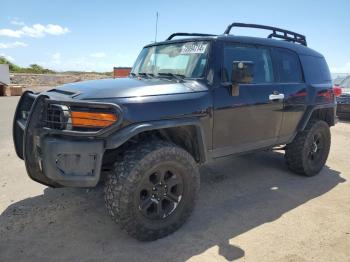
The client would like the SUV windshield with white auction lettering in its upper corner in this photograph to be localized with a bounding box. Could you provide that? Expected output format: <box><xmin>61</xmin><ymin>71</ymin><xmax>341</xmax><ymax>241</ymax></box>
<box><xmin>131</xmin><ymin>41</ymin><xmax>209</xmax><ymax>78</ymax></box>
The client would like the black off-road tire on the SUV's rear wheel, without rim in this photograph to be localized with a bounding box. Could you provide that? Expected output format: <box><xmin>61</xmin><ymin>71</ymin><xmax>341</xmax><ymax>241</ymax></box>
<box><xmin>285</xmin><ymin>120</ymin><xmax>331</xmax><ymax>176</ymax></box>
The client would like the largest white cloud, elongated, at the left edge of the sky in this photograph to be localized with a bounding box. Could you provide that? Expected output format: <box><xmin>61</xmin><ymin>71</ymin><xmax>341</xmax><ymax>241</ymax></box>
<box><xmin>0</xmin><ymin>24</ymin><xmax>70</xmax><ymax>38</ymax></box>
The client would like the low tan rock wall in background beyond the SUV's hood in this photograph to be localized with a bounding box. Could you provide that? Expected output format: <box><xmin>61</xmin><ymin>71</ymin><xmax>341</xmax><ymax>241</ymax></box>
<box><xmin>10</xmin><ymin>73</ymin><xmax>111</xmax><ymax>88</ymax></box>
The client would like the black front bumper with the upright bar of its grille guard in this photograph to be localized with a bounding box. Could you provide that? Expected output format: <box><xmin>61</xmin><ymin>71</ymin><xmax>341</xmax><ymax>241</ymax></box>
<box><xmin>13</xmin><ymin>92</ymin><xmax>105</xmax><ymax>187</ymax></box>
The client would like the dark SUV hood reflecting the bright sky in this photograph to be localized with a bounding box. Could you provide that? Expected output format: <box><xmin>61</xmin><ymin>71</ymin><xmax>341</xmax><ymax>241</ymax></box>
<box><xmin>50</xmin><ymin>78</ymin><xmax>207</xmax><ymax>99</ymax></box>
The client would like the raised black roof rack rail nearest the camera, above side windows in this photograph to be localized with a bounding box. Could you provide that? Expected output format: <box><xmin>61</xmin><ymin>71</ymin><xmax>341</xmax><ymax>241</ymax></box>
<box><xmin>224</xmin><ymin>23</ymin><xmax>307</xmax><ymax>46</ymax></box>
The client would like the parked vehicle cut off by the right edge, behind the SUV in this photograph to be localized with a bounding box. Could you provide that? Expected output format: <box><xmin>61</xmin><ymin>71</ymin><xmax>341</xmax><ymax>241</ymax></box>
<box><xmin>337</xmin><ymin>76</ymin><xmax>350</xmax><ymax>120</ymax></box>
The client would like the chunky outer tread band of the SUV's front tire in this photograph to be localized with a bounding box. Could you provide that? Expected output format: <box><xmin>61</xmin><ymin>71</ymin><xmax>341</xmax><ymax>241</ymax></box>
<box><xmin>105</xmin><ymin>139</ymin><xmax>199</xmax><ymax>241</ymax></box>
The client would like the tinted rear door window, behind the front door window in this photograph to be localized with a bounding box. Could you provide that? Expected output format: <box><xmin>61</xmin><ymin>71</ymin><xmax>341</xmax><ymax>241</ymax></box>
<box><xmin>275</xmin><ymin>49</ymin><xmax>303</xmax><ymax>83</ymax></box>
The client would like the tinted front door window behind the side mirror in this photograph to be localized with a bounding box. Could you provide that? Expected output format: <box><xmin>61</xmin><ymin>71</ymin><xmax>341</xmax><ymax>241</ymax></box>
<box><xmin>222</xmin><ymin>45</ymin><xmax>274</xmax><ymax>84</ymax></box>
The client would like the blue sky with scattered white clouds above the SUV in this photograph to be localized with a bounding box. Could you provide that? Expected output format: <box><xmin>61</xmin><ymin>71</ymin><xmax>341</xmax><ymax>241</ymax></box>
<box><xmin>0</xmin><ymin>0</ymin><xmax>350</xmax><ymax>73</ymax></box>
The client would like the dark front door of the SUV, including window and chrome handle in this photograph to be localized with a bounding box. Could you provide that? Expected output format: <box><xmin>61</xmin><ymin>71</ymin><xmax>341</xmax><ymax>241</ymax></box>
<box><xmin>213</xmin><ymin>43</ymin><xmax>284</xmax><ymax>157</ymax></box>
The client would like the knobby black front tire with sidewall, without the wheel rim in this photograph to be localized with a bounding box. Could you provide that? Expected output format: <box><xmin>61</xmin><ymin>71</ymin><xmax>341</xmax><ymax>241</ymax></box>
<box><xmin>105</xmin><ymin>140</ymin><xmax>200</xmax><ymax>241</ymax></box>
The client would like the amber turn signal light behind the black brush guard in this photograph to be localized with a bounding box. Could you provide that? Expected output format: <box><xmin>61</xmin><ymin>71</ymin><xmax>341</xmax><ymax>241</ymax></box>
<box><xmin>71</xmin><ymin>111</ymin><xmax>118</xmax><ymax>127</ymax></box>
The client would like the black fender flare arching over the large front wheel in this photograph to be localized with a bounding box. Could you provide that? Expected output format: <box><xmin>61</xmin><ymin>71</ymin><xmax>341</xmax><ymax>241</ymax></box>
<box><xmin>105</xmin><ymin>118</ymin><xmax>207</xmax><ymax>163</ymax></box>
